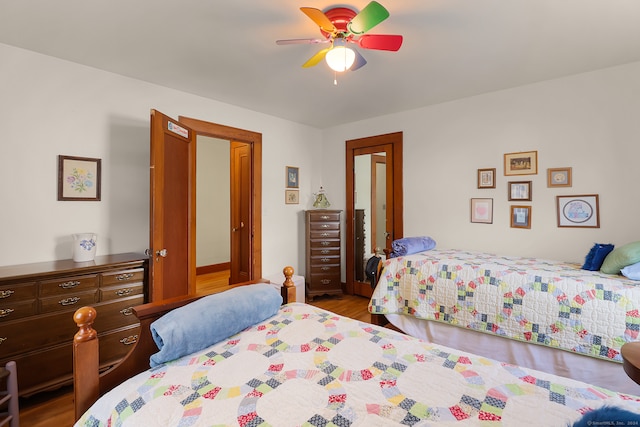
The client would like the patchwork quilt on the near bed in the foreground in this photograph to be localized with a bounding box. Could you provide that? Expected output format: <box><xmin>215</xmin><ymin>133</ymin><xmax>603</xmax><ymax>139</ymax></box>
<box><xmin>76</xmin><ymin>303</ymin><xmax>640</xmax><ymax>427</ymax></box>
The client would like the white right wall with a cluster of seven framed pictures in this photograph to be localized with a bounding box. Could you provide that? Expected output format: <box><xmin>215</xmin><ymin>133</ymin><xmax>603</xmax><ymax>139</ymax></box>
<box><xmin>323</xmin><ymin>63</ymin><xmax>640</xmax><ymax>262</ymax></box>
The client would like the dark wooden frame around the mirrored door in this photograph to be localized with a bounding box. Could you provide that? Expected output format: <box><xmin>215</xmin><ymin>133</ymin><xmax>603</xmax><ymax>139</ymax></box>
<box><xmin>345</xmin><ymin>132</ymin><xmax>404</xmax><ymax>295</ymax></box>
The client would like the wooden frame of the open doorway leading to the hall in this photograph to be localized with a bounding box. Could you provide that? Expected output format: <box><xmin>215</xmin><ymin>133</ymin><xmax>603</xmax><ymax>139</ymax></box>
<box><xmin>178</xmin><ymin>116</ymin><xmax>262</xmax><ymax>280</ymax></box>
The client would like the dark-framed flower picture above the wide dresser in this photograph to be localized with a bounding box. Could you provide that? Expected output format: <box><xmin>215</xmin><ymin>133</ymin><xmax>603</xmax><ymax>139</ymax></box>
<box><xmin>58</xmin><ymin>155</ymin><xmax>101</xmax><ymax>201</ymax></box>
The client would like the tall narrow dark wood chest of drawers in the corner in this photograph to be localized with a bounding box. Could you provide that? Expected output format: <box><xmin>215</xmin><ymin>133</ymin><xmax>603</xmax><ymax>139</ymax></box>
<box><xmin>305</xmin><ymin>209</ymin><xmax>342</xmax><ymax>301</ymax></box>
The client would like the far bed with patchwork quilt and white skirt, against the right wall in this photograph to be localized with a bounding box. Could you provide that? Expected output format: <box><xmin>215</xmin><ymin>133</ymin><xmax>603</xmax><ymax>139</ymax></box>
<box><xmin>369</xmin><ymin>249</ymin><xmax>640</xmax><ymax>393</ymax></box>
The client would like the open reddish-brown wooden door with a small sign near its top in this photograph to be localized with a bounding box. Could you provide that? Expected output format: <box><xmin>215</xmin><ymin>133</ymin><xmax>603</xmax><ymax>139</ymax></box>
<box><xmin>149</xmin><ymin>110</ymin><xmax>196</xmax><ymax>301</ymax></box>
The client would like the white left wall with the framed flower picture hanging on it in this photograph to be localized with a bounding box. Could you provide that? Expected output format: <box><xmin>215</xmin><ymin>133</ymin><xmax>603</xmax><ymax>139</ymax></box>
<box><xmin>0</xmin><ymin>44</ymin><xmax>321</xmax><ymax>275</ymax></box>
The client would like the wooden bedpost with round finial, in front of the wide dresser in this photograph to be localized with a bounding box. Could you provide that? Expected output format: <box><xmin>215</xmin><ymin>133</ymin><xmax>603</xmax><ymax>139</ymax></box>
<box><xmin>73</xmin><ymin>307</ymin><xmax>100</xmax><ymax>420</ymax></box>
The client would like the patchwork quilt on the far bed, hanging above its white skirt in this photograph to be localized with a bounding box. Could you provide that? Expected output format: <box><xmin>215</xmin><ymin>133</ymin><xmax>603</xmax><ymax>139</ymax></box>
<box><xmin>369</xmin><ymin>249</ymin><xmax>640</xmax><ymax>362</ymax></box>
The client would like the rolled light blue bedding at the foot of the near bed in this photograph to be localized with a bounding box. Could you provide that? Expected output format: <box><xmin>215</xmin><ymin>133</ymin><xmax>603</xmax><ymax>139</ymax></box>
<box><xmin>150</xmin><ymin>284</ymin><xmax>282</xmax><ymax>368</ymax></box>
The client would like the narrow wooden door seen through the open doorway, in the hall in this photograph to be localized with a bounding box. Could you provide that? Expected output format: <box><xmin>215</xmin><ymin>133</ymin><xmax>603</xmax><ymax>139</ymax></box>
<box><xmin>229</xmin><ymin>141</ymin><xmax>253</xmax><ymax>284</ymax></box>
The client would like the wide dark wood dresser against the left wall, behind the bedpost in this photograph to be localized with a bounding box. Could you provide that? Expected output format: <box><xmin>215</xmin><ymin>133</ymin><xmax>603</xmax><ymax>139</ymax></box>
<box><xmin>0</xmin><ymin>253</ymin><xmax>148</xmax><ymax>396</ymax></box>
